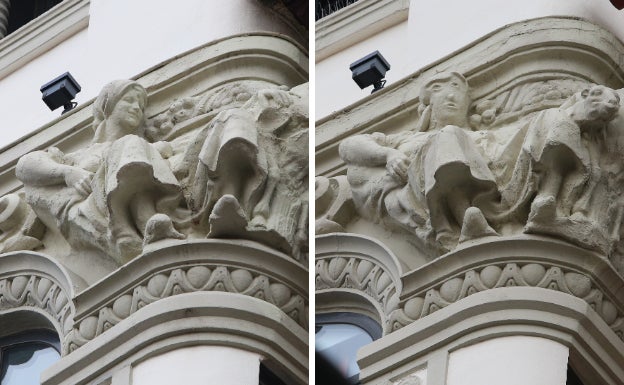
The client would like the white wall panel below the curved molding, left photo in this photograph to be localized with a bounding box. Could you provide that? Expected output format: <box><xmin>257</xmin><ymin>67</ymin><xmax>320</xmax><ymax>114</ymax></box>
<box><xmin>131</xmin><ymin>346</ymin><xmax>261</xmax><ymax>385</ymax></box>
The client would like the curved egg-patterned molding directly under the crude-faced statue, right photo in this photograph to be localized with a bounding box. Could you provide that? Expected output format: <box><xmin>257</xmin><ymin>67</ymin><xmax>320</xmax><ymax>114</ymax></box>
<box><xmin>386</xmin><ymin>235</ymin><xmax>624</xmax><ymax>339</ymax></box>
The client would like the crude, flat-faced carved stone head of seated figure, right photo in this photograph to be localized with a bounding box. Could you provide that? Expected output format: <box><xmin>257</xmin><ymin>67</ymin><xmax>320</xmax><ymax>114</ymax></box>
<box><xmin>420</xmin><ymin>72</ymin><xmax>471</xmax><ymax>129</ymax></box>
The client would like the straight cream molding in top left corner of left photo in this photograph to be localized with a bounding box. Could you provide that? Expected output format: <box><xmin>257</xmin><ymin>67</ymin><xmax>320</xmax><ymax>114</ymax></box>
<box><xmin>0</xmin><ymin>0</ymin><xmax>91</xmax><ymax>79</ymax></box>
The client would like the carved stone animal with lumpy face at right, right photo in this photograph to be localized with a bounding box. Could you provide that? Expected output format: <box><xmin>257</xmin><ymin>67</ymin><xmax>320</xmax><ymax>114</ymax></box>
<box><xmin>514</xmin><ymin>85</ymin><xmax>620</xmax><ymax>252</ymax></box>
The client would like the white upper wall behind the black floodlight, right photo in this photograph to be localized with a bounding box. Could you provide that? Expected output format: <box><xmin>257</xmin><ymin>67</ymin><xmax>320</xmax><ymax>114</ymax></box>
<box><xmin>315</xmin><ymin>0</ymin><xmax>624</xmax><ymax>119</ymax></box>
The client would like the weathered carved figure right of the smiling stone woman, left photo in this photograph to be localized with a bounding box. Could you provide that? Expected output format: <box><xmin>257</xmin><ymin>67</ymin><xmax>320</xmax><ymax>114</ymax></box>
<box><xmin>178</xmin><ymin>85</ymin><xmax>308</xmax><ymax>255</ymax></box>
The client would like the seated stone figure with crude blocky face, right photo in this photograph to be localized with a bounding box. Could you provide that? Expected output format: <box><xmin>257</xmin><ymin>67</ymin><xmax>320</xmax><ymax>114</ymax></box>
<box><xmin>340</xmin><ymin>72</ymin><xmax>498</xmax><ymax>251</ymax></box>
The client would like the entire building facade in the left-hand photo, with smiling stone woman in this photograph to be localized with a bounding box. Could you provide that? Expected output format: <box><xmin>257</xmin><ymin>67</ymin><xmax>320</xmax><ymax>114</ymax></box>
<box><xmin>0</xmin><ymin>0</ymin><xmax>308</xmax><ymax>385</ymax></box>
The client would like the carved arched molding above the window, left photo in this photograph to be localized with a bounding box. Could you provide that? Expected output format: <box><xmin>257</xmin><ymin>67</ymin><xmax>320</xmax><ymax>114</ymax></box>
<box><xmin>0</xmin><ymin>251</ymin><xmax>78</xmax><ymax>340</ymax></box>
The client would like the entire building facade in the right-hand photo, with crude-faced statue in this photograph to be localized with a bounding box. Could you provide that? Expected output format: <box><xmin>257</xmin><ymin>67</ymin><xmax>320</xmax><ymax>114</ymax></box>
<box><xmin>315</xmin><ymin>0</ymin><xmax>624</xmax><ymax>385</ymax></box>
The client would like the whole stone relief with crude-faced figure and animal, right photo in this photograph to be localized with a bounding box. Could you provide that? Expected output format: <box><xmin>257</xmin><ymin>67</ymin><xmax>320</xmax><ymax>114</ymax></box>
<box><xmin>334</xmin><ymin>73</ymin><xmax>624</xmax><ymax>273</ymax></box>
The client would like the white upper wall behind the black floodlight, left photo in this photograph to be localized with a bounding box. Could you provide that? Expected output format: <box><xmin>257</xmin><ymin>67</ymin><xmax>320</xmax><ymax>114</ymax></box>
<box><xmin>0</xmin><ymin>0</ymin><xmax>300</xmax><ymax>147</ymax></box>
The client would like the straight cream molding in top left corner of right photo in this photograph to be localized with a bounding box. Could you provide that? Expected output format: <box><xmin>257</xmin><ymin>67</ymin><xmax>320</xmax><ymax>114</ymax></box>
<box><xmin>315</xmin><ymin>0</ymin><xmax>410</xmax><ymax>62</ymax></box>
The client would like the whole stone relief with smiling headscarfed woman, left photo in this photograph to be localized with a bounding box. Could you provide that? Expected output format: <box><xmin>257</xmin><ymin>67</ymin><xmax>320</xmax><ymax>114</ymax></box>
<box><xmin>11</xmin><ymin>80</ymin><xmax>308</xmax><ymax>264</ymax></box>
